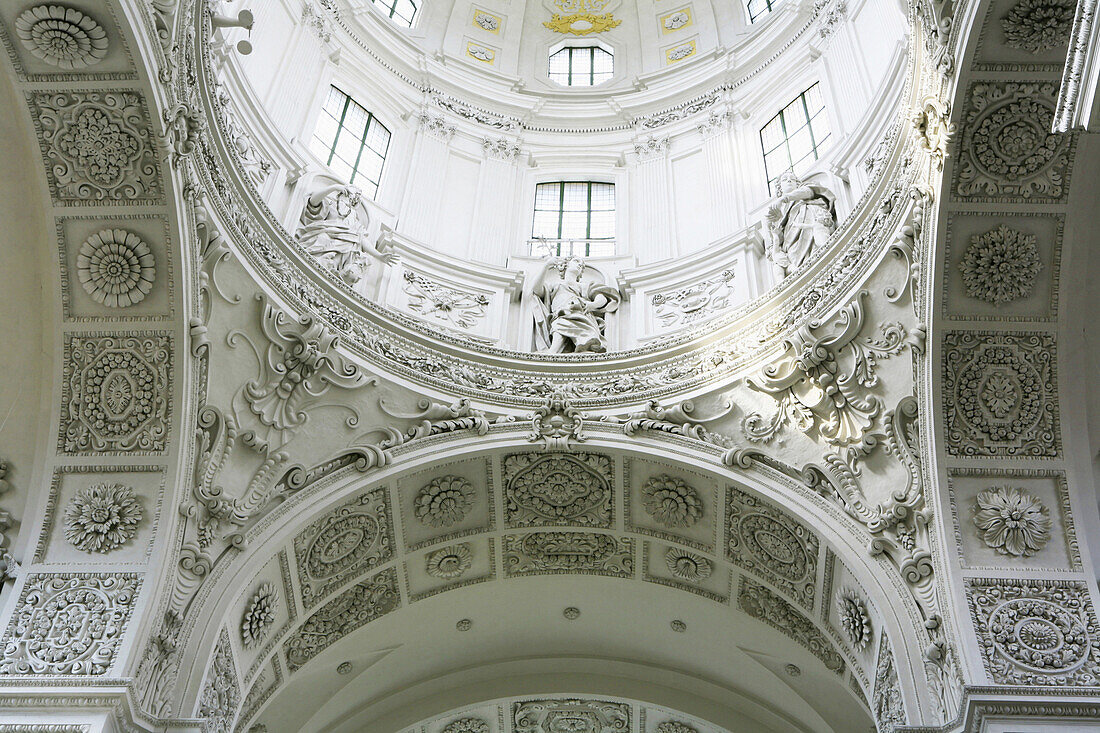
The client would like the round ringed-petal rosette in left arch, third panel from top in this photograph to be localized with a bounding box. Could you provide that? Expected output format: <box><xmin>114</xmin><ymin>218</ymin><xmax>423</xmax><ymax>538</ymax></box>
<box><xmin>76</xmin><ymin>229</ymin><xmax>156</xmax><ymax>308</ymax></box>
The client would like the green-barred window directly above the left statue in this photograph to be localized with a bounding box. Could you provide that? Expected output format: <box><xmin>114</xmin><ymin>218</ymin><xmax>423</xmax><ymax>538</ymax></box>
<box><xmin>309</xmin><ymin>87</ymin><xmax>389</xmax><ymax>198</ymax></box>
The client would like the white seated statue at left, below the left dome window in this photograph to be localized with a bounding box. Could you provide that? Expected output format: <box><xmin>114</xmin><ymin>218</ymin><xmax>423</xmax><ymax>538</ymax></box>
<box><xmin>296</xmin><ymin>184</ymin><xmax>398</xmax><ymax>285</ymax></box>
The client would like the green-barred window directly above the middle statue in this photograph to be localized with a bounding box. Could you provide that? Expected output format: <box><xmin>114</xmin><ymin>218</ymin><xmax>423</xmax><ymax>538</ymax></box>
<box><xmin>531</xmin><ymin>180</ymin><xmax>615</xmax><ymax>256</ymax></box>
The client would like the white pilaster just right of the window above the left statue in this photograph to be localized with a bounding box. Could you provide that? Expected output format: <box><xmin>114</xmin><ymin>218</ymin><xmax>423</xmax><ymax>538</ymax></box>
<box><xmin>396</xmin><ymin>111</ymin><xmax>454</xmax><ymax>242</ymax></box>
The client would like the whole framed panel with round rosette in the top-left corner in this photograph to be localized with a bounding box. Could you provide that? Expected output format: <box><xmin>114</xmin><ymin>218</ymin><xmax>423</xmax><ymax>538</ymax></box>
<box><xmin>0</xmin><ymin>0</ymin><xmax>138</xmax><ymax>81</ymax></box>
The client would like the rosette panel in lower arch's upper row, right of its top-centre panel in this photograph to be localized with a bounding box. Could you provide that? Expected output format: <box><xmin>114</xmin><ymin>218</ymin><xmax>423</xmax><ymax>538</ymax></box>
<box><xmin>624</xmin><ymin>458</ymin><xmax>719</xmax><ymax>553</ymax></box>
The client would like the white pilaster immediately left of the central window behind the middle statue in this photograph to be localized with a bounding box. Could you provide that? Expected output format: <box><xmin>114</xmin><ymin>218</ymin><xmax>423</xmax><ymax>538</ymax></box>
<box><xmin>470</xmin><ymin>138</ymin><xmax>520</xmax><ymax>267</ymax></box>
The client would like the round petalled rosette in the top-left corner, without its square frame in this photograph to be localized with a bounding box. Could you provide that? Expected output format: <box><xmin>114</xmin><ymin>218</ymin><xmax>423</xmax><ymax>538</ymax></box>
<box><xmin>15</xmin><ymin>4</ymin><xmax>109</xmax><ymax>69</ymax></box>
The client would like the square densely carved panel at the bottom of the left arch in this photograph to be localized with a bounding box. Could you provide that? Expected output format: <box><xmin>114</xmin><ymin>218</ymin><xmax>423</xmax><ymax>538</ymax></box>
<box><xmin>0</xmin><ymin>573</ymin><xmax>141</xmax><ymax>675</ymax></box>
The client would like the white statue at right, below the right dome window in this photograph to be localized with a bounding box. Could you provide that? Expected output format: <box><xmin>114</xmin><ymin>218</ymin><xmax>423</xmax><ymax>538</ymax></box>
<box><xmin>763</xmin><ymin>171</ymin><xmax>836</xmax><ymax>277</ymax></box>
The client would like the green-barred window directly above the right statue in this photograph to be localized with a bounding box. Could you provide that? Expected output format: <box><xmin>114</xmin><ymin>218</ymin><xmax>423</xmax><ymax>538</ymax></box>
<box><xmin>760</xmin><ymin>84</ymin><xmax>829</xmax><ymax>190</ymax></box>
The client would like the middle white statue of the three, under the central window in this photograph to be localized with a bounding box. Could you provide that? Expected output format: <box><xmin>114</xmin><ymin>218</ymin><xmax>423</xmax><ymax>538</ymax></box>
<box><xmin>525</xmin><ymin>258</ymin><xmax>622</xmax><ymax>353</ymax></box>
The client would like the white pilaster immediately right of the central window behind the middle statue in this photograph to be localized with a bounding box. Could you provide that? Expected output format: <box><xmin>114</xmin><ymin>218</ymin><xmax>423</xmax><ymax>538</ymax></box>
<box><xmin>627</xmin><ymin>138</ymin><xmax>679</xmax><ymax>264</ymax></box>
